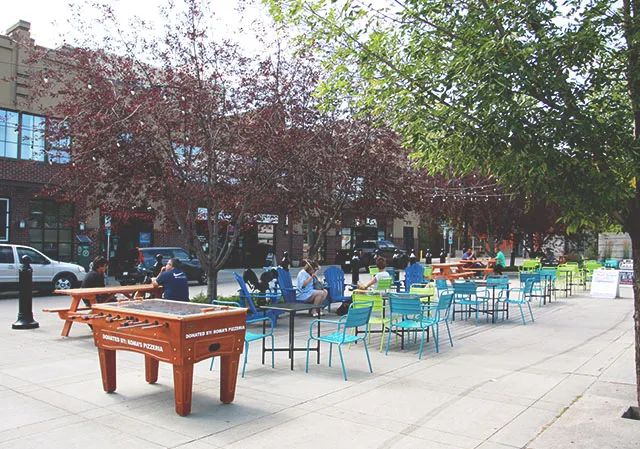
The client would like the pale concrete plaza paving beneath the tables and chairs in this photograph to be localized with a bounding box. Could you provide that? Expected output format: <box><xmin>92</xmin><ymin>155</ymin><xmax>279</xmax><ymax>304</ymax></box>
<box><xmin>0</xmin><ymin>287</ymin><xmax>640</xmax><ymax>449</ymax></box>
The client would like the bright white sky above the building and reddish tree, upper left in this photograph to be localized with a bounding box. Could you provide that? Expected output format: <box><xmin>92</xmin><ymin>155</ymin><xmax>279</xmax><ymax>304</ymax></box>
<box><xmin>0</xmin><ymin>0</ymin><xmax>270</xmax><ymax>48</ymax></box>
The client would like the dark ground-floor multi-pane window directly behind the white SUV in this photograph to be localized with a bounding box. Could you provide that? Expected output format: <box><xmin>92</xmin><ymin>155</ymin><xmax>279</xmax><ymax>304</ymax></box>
<box><xmin>29</xmin><ymin>200</ymin><xmax>73</xmax><ymax>262</ymax></box>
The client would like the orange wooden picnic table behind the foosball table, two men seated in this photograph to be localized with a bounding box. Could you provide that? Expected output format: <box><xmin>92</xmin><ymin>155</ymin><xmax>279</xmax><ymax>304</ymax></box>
<box><xmin>42</xmin><ymin>284</ymin><xmax>162</xmax><ymax>337</ymax></box>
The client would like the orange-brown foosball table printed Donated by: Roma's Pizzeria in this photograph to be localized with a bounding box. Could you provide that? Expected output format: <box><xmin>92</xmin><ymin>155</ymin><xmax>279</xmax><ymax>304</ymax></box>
<box><xmin>92</xmin><ymin>299</ymin><xmax>247</xmax><ymax>416</ymax></box>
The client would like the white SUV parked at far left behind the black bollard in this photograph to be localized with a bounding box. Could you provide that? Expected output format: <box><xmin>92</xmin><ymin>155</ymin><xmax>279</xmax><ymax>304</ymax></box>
<box><xmin>0</xmin><ymin>244</ymin><xmax>86</xmax><ymax>291</ymax></box>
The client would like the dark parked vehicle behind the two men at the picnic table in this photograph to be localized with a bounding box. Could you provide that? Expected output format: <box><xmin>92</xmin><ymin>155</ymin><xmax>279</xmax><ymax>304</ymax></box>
<box><xmin>116</xmin><ymin>246</ymin><xmax>207</xmax><ymax>285</ymax></box>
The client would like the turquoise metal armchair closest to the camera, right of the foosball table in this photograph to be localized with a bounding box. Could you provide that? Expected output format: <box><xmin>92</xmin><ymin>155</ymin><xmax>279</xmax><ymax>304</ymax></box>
<box><xmin>305</xmin><ymin>301</ymin><xmax>373</xmax><ymax>380</ymax></box>
